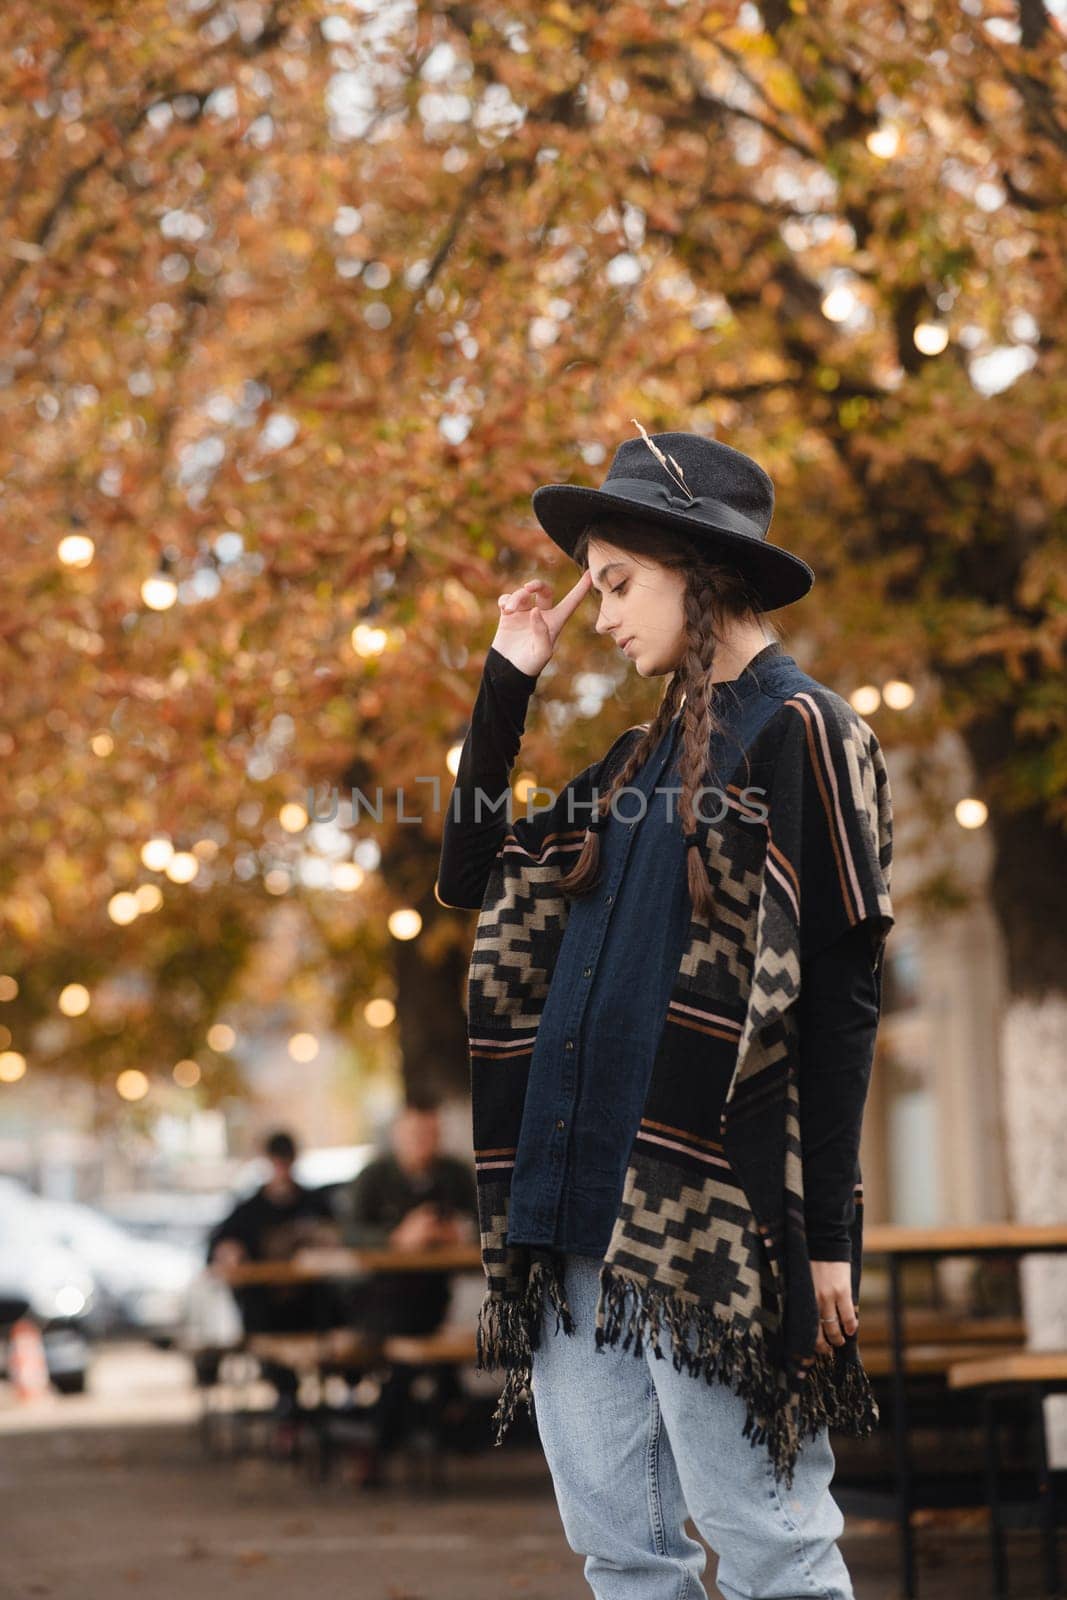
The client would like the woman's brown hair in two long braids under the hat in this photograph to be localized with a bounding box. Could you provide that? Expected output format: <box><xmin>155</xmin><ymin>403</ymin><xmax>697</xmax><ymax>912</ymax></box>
<box><xmin>560</xmin><ymin>517</ymin><xmax>777</xmax><ymax>922</ymax></box>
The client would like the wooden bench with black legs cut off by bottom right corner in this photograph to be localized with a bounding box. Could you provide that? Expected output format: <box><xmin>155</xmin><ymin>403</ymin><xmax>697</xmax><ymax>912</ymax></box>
<box><xmin>949</xmin><ymin>1350</ymin><xmax>1067</xmax><ymax>1600</ymax></box>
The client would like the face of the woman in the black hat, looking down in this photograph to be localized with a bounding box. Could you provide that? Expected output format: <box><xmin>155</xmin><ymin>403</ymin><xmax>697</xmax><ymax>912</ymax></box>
<box><xmin>585</xmin><ymin>539</ymin><xmax>685</xmax><ymax>678</ymax></box>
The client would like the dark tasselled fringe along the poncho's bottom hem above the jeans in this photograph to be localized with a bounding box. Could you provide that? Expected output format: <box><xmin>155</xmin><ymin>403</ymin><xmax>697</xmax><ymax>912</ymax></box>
<box><xmin>477</xmin><ymin>1256</ymin><xmax>878</xmax><ymax>1488</ymax></box>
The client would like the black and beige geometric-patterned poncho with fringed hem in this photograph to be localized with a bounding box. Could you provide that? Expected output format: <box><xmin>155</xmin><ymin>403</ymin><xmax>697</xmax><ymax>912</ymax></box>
<box><xmin>467</xmin><ymin>675</ymin><xmax>894</xmax><ymax>1483</ymax></box>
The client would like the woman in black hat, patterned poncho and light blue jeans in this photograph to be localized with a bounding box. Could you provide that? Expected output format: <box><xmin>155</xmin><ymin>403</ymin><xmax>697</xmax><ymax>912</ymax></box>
<box><xmin>438</xmin><ymin>424</ymin><xmax>893</xmax><ymax>1600</ymax></box>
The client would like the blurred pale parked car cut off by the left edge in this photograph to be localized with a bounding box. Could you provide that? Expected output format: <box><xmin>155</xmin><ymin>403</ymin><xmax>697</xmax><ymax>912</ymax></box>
<box><xmin>0</xmin><ymin>1178</ymin><xmax>96</xmax><ymax>1394</ymax></box>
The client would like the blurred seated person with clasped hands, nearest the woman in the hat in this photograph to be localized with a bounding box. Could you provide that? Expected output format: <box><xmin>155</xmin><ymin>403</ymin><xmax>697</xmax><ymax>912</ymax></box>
<box><xmin>338</xmin><ymin>1094</ymin><xmax>478</xmax><ymax>1485</ymax></box>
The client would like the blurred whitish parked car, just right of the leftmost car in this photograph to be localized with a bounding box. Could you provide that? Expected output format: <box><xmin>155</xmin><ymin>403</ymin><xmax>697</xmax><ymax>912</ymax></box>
<box><xmin>40</xmin><ymin>1200</ymin><xmax>203</xmax><ymax>1346</ymax></box>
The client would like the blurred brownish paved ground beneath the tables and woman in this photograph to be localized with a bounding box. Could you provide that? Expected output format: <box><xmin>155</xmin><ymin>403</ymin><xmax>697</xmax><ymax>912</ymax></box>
<box><xmin>0</xmin><ymin>1349</ymin><xmax>1040</xmax><ymax>1600</ymax></box>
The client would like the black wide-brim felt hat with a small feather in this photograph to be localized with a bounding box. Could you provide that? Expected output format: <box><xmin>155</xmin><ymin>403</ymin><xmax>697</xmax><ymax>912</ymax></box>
<box><xmin>533</xmin><ymin>422</ymin><xmax>816</xmax><ymax>611</ymax></box>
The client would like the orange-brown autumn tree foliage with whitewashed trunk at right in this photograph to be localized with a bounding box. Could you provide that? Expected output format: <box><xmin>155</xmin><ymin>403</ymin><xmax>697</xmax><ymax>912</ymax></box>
<box><xmin>0</xmin><ymin>0</ymin><xmax>1067</xmax><ymax>1299</ymax></box>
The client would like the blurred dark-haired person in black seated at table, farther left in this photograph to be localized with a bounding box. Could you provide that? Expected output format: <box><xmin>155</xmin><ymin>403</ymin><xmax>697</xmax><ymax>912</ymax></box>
<box><xmin>208</xmin><ymin>1131</ymin><xmax>342</xmax><ymax>1411</ymax></box>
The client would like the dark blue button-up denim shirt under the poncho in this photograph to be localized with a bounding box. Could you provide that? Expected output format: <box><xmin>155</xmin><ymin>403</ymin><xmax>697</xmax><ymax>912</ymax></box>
<box><xmin>507</xmin><ymin>642</ymin><xmax>797</xmax><ymax>1258</ymax></box>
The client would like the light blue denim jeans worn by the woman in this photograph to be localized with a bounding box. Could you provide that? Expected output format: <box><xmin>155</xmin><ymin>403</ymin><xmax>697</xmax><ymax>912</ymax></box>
<box><xmin>531</xmin><ymin>1254</ymin><xmax>853</xmax><ymax>1600</ymax></box>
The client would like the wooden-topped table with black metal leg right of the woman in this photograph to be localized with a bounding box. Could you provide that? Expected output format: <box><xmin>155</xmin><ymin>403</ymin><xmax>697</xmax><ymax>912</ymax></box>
<box><xmin>861</xmin><ymin>1222</ymin><xmax>1067</xmax><ymax>1600</ymax></box>
